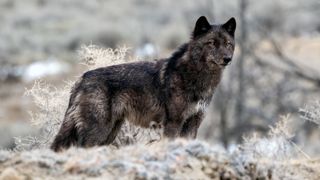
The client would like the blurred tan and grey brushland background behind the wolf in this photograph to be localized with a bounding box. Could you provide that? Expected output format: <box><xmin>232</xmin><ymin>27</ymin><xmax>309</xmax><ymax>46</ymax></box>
<box><xmin>0</xmin><ymin>0</ymin><xmax>320</xmax><ymax>154</ymax></box>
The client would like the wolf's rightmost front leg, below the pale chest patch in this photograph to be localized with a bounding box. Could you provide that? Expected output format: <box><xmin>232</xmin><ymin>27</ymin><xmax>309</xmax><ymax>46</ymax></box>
<box><xmin>180</xmin><ymin>111</ymin><xmax>203</xmax><ymax>139</ymax></box>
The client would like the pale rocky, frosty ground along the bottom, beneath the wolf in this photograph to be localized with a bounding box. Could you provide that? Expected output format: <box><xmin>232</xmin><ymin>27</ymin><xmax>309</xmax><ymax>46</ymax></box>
<box><xmin>0</xmin><ymin>140</ymin><xmax>320</xmax><ymax>180</ymax></box>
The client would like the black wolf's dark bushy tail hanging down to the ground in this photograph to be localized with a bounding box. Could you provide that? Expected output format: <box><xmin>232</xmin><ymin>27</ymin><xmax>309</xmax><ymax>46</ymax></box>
<box><xmin>50</xmin><ymin>121</ymin><xmax>78</xmax><ymax>152</ymax></box>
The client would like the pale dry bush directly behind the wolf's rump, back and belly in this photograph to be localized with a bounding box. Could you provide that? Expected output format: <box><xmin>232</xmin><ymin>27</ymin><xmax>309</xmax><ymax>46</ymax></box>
<box><xmin>16</xmin><ymin>45</ymin><xmax>161</xmax><ymax>150</ymax></box>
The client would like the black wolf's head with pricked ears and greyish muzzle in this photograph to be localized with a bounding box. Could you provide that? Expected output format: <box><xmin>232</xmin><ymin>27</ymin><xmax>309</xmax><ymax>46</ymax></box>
<box><xmin>190</xmin><ymin>16</ymin><xmax>236</xmax><ymax>68</ymax></box>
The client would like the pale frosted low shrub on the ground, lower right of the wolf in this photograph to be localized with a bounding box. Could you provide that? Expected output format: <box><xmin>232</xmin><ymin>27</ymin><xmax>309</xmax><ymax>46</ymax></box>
<box><xmin>231</xmin><ymin>116</ymin><xmax>311</xmax><ymax>179</ymax></box>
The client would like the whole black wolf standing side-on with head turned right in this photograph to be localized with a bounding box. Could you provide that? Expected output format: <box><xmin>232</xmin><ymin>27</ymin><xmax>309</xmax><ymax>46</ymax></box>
<box><xmin>51</xmin><ymin>16</ymin><xmax>236</xmax><ymax>151</ymax></box>
